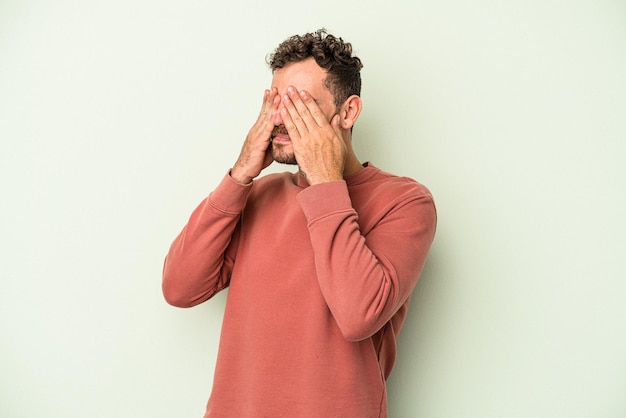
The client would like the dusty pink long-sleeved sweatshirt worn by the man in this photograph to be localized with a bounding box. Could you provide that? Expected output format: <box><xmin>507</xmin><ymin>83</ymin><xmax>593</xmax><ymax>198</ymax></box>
<box><xmin>163</xmin><ymin>164</ymin><xmax>436</xmax><ymax>418</ymax></box>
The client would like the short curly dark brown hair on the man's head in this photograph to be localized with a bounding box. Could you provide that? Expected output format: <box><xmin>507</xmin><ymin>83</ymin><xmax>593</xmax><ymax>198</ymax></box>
<box><xmin>267</xmin><ymin>29</ymin><xmax>363</xmax><ymax>107</ymax></box>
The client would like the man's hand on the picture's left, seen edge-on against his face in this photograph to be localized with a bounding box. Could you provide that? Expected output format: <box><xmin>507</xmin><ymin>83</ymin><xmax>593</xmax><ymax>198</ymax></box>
<box><xmin>230</xmin><ymin>88</ymin><xmax>280</xmax><ymax>184</ymax></box>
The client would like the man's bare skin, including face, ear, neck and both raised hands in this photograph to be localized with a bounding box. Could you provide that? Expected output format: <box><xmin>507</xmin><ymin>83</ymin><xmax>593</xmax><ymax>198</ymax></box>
<box><xmin>230</xmin><ymin>58</ymin><xmax>363</xmax><ymax>185</ymax></box>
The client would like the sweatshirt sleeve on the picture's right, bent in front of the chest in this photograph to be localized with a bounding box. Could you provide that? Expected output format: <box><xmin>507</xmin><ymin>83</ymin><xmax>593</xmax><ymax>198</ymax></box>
<box><xmin>297</xmin><ymin>181</ymin><xmax>436</xmax><ymax>341</ymax></box>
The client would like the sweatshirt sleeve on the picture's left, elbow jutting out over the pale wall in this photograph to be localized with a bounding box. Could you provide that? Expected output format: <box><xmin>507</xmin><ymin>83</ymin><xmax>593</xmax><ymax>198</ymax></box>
<box><xmin>162</xmin><ymin>174</ymin><xmax>251</xmax><ymax>308</ymax></box>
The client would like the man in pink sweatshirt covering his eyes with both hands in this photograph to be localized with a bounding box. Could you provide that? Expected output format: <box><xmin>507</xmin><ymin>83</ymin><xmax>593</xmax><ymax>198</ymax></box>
<box><xmin>163</xmin><ymin>30</ymin><xmax>436</xmax><ymax>418</ymax></box>
